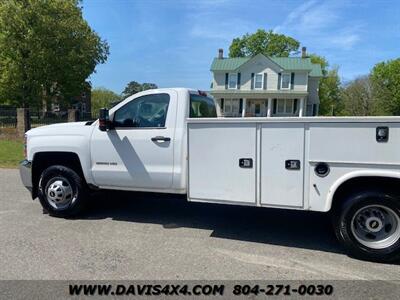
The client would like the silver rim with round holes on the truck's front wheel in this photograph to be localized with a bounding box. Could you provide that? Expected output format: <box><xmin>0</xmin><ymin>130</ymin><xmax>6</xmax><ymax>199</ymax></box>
<box><xmin>46</xmin><ymin>177</ymin><xmax>77</xmax><ymax>210</ymax></box>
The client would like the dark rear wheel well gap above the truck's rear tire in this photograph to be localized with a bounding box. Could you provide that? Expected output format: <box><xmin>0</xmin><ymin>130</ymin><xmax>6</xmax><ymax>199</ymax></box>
<box><xmin>331</xmin><ymin>176</ymin><xmax>400</xmax><ymax>209</ymax></box>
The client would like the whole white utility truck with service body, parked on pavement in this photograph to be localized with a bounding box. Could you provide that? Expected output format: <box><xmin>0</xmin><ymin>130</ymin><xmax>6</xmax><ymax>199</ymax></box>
<box><xmin>20</xmin><ymin>88</ymin><xmax>400</xmax><ymax>261</ymax></box>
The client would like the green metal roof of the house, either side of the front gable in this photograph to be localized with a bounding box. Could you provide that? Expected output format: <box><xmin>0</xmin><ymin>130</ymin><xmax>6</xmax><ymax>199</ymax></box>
<box><xmin>211</xmin><ymin>56</ymin><xmax>322</xmax><ymax>76</ymax></box>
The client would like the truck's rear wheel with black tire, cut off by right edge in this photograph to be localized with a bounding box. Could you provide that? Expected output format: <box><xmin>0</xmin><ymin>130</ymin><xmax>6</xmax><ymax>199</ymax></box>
<box><xmin>333</xmin><ymin>190</ymin><xmax>400</xmax><ymax>262</ymax></box>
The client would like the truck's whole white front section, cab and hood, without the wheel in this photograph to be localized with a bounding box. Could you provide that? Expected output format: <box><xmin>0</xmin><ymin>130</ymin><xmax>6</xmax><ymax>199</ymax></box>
<box><xmin>21</xmin><ymin>88</ymin><xmax>217</xmax><ymax>198</ymax></box>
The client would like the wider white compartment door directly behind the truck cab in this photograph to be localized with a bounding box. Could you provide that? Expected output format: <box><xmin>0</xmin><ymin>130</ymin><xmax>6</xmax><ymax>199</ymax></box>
<box><xmin>188</xmin><ymin>123</ymin><xmax>256</xmax><ymax>205</ymax></box>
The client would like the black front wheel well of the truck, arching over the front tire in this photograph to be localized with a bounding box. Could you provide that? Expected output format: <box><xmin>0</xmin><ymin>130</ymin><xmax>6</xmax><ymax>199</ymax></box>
<box><xmin>32</xmin><ymin>152</ymin><xmax>85</xmax><ymax>198</ymax></box>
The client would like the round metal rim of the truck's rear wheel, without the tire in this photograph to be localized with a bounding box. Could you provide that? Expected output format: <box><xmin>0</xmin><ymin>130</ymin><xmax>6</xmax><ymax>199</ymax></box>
<box><xmin>351</xmin><ymin>205</ymin><xmax>400</xmax><ymax>249</ymax></box>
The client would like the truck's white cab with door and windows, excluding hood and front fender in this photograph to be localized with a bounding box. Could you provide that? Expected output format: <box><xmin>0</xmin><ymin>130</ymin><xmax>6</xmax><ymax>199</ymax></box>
<box><xmin>90</xmin><ymin>89</ymin><xmax>216</xmax><ymax>194</ymax></box>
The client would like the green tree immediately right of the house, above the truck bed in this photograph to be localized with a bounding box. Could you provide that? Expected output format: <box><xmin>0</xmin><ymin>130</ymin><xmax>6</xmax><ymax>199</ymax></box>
<box><xmin>308</xmin><ymin>54</ymin><xmax>343</xmax><ymax>116</ymax></box>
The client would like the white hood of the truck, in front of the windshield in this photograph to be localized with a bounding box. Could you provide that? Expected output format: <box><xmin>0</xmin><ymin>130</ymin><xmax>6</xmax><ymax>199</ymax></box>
<box><xmin>26</xmin><ymin>122</ymin><xmax>93</xmax><ymax>136</ymax></box>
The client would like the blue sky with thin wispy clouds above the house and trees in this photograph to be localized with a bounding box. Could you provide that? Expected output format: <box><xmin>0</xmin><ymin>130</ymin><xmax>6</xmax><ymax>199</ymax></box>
<box><xmin>82</xmin><ymin>0</ymin><xmax>400</xmax><ymax>94</ymax></box>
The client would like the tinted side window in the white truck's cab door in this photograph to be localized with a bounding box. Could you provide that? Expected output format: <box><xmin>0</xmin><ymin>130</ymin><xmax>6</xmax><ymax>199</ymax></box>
<box><xmin>114</xmin><ymin>94</ymin><xmax>169</xmax><ymax>128</ymax></box>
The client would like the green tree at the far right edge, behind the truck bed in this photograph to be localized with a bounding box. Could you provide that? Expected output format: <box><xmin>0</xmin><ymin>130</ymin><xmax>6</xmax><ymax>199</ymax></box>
<box><xmin>371</xmin><ymin>58</ymin><xmax>400</xmax><ymax>116</ymax></box>
